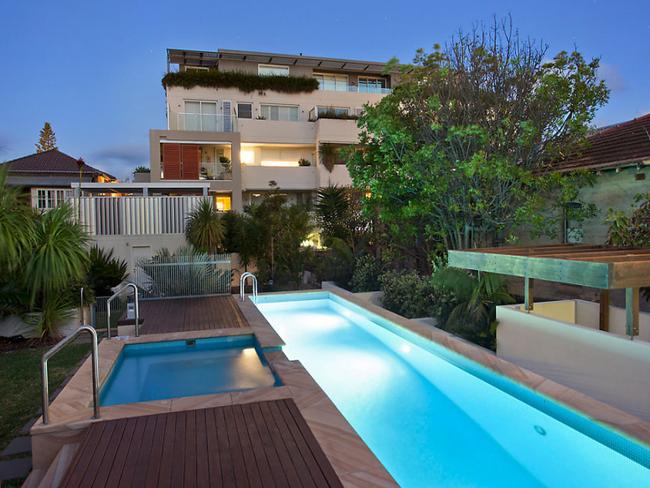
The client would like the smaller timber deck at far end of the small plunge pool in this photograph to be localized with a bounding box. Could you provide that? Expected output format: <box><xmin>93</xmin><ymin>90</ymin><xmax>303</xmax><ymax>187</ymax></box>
<box><xmin>140</xmin><ymin>296</ymin><xmax>248</xmax><ymax>334</ymax></box>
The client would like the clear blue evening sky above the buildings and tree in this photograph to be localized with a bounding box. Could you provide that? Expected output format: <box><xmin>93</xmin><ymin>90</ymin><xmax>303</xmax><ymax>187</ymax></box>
<box><xmin>0</xmin><ymin>0</ymin><xmax>650</xmax><ymax>179</ymax></box>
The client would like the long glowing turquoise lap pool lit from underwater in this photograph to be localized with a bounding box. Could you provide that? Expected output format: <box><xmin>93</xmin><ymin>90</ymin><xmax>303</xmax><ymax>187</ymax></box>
<box><xmin>257</xmin><ymin>292</ymin><xmax>650</xmax><ymax>488</ymax></box>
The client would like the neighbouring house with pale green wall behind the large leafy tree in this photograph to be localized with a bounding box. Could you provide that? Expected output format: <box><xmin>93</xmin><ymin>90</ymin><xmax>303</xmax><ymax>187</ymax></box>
<box><xmin>555</xmin><ymin>114</ymin><xmax>650</xmax><ymax>244</ymax></box>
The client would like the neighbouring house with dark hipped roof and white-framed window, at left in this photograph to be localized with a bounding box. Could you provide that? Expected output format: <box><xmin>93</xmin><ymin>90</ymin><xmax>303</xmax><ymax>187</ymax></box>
<box><xmin>1</xmin><ymin>149</ymin><xmax>116</xmax><ymax>210</ymax></box>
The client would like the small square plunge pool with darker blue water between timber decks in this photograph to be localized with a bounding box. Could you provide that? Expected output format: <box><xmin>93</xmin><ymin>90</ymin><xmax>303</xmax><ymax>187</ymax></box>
<box><xmin>100</xmin><ymin>335</ymin><xmax>278</xmax><ymax>406</ymax></box>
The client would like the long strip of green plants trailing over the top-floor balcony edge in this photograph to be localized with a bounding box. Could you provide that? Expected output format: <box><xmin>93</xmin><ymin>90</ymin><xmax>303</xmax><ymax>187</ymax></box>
<box><xmin>162</xmin><ymin>70</ymin><xmax>318</xmax><ymax>93</ymax></box>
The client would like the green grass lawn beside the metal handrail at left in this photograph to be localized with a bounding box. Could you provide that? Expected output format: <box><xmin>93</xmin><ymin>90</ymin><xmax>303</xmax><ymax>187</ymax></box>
<box><xmin>0</xmin><ymin>343</ymin><xmax>90</xmax><ymax>451</ymax></box>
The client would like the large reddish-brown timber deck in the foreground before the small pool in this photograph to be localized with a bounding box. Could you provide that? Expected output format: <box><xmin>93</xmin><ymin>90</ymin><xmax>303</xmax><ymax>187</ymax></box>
<box><xmin>61</xmin><ymin>399</ymin><xmax>342</xmax><ymax>487</ymax></box>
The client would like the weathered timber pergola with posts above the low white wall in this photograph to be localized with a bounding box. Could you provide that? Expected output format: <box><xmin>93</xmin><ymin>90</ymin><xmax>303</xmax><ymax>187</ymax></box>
<box><xmin>449</xmin><ymin>244</ymin><xmax>650</xmax><ymax>338</ymax></box>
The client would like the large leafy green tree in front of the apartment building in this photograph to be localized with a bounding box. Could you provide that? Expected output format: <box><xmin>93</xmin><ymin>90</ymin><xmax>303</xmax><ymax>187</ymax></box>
<box><xmin>348</xmin><ymin>19</ymin><xmax>608</xmax><ymax>263</ymax></box>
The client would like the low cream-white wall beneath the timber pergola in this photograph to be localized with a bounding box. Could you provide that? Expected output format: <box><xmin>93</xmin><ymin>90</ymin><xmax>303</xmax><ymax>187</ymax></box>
<box><xmin>497</xmin><ymin>302</ymin><xmax>650</xmax><ymax>420</ymax></box>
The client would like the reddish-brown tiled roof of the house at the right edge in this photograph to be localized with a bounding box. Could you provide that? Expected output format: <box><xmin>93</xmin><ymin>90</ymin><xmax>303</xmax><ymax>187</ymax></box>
<box><xmin>553</xmin><ymin>114</ymin><xmax>650</xmax><ymax>171</ymax></box>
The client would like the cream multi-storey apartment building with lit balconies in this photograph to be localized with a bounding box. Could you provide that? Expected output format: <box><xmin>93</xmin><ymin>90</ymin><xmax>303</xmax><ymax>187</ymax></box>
<box><xmin>150</xmin><ymin>49</ymin><xmax>398</xmax><ymax>210</ymax></box>
